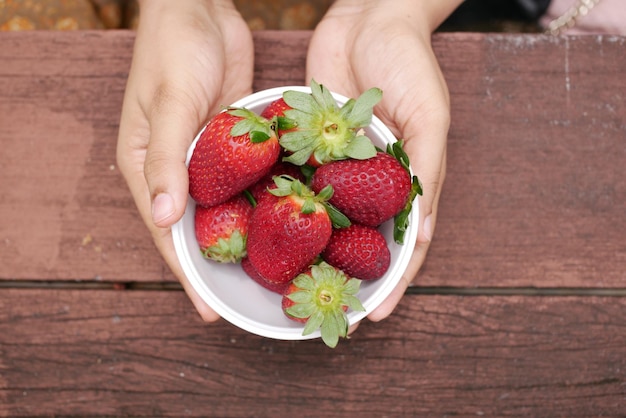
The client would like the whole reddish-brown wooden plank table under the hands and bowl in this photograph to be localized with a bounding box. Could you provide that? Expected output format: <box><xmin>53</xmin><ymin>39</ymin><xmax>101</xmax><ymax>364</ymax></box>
<box><xmin>0</xmin><ymin>31</ymin><xmax>626</xmax><ymax>417</ymax></box>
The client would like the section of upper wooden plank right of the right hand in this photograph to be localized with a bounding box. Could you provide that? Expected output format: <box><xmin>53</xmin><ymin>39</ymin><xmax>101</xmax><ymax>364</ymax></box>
<box><xmin>420</xmin><ymin>35</ymin><xmax>626</xmax><ymax>287</ymax></box>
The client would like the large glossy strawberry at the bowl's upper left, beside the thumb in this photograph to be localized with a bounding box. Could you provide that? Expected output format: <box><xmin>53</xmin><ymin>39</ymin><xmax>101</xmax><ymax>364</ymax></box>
<box><xmin>189</xmin><ymin>109</ymin><xmax>280</xmax><ymax>206</ymax></box>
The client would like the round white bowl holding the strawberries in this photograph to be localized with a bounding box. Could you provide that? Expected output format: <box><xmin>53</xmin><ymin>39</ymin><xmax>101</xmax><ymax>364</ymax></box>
<box><xmin>172</xmin><ymin>86</ymin><xmax>419</xmax><ymax>340</ymax></box>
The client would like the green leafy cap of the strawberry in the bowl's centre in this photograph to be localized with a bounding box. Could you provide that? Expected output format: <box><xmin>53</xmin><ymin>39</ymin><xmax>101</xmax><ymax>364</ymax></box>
<box><xmin>267</xmin><ymin>175</ymin><xmax>351</xmax><ymax>228</ymax></box>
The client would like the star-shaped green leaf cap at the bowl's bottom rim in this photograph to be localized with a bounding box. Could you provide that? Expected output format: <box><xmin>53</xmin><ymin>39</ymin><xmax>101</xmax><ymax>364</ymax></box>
<box><xmin>285</xmin><ymin>261</ymin><xmax>365</xmax><ymax>348</ymax></box>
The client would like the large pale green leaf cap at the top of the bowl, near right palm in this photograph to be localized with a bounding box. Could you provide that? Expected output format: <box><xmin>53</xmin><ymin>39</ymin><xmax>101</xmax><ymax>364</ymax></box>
<box><xmin>279</xmin><ymin>80</ymin><xmax>382</xmax><ymax>165</ymax></box>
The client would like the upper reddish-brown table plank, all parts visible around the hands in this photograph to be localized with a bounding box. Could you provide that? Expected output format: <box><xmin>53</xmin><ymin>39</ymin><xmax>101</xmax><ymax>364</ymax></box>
<box><xmin>0</xmin><ymin>31</ymin><xmax>626</xmax><ymax>288</ymax></box>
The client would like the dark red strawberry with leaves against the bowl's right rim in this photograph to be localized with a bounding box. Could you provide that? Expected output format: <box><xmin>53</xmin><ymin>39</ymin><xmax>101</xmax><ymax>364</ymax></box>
<box><xmin>311</xmin><ymin>141</ymin><xmax>422</xmax><ymax>244</ymax></box>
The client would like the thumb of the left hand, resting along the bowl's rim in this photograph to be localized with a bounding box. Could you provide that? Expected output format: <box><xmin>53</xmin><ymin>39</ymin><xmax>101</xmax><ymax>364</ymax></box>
<box><xmin>144</xmin><ymin>87</ymin><xmax>201</xmax><ymax>228</ymax></box>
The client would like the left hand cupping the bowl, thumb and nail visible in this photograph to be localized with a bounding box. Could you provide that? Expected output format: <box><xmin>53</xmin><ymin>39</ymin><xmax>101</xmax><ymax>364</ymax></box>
<box><xmin>117</xmin><ymin>0</ymin><xmax>254</xmax><ymax>321</ymax></box>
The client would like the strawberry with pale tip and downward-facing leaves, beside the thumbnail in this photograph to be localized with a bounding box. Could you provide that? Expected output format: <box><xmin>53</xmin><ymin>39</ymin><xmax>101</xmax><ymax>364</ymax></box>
<box><xmin>195</xmin><ymin>195</ymin><xmax>252</xmax><ymax>263</ymax></box>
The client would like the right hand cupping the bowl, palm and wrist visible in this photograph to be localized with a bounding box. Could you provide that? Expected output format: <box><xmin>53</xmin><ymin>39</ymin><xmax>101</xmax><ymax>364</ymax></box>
<box><xmin>307</xmin><ymin>0</ymin><xmax>460</xmax><ymax>321</ymax></box>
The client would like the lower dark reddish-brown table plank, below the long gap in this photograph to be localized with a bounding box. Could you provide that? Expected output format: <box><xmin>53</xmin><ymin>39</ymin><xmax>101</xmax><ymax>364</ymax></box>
<box><xmin>0</xmin><ymin>289</ymin><xmax>626</xmax><ymax>417</ymax></box>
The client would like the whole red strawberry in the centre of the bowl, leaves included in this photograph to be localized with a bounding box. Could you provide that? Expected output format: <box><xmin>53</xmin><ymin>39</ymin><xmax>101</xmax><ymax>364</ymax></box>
<box><xmin>248</xmin><ymin>176</ymin><xmax>348</xmax><ymax>283</ymax></box>
